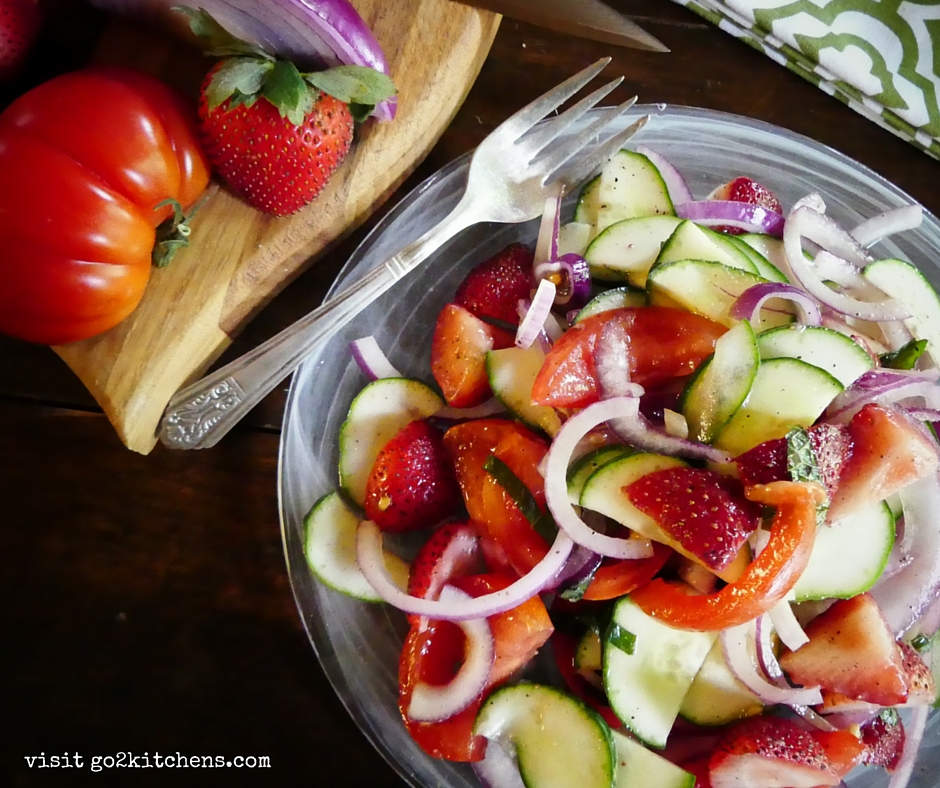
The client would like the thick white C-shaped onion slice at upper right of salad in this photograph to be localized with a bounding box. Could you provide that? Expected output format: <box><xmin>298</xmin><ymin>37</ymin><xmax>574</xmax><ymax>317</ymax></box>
<box><xmin>783</xmin><ymin>207</ymin><xmax>911</xmax><ymax>323</ymax></box>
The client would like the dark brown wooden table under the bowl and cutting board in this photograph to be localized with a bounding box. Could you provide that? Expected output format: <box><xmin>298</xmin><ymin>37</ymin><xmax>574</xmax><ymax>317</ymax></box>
<box><xmin>0</xmin><ymin>0</ymin><xmax>940</xmax><ymax>788</ymax></box>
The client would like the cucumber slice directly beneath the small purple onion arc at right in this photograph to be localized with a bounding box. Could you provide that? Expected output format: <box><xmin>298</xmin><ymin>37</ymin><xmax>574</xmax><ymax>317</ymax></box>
<box><xmin>757</xmin><ymin>326</ymin><xmax>875</xmax><ymax>388</ymax></box>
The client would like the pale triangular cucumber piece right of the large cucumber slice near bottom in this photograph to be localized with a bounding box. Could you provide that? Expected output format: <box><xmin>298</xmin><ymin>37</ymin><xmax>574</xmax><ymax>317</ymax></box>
<box><xmin>679</xmin><ymin>640</ymin><xmax>764</xmax><ymax>726</ymax></box>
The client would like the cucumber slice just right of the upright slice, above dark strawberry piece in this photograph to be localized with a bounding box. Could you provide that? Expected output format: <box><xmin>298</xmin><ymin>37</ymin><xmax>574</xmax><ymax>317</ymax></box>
<box><xmin>713</xmin><ymin>358</ymin><xmax>843</xmax><ymax>456</ymax></box>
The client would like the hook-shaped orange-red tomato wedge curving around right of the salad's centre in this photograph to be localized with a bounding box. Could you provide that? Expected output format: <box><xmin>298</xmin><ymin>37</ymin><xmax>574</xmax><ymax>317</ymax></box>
<box><xmin>631</xmin><ymin>481</ymin><xmax>826</xmax><ymax>631</ymax></box>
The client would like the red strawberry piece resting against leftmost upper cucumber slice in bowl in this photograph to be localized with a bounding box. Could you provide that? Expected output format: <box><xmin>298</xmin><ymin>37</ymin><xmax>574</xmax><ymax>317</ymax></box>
<box><xmin>363</xmin><ymin>420</ymin><xmax>460</xmax><ymax>531</ymax></box>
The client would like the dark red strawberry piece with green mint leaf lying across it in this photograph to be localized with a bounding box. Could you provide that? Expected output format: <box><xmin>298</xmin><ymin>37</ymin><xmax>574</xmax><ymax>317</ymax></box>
<box><xmin>735</xmin><ymin>424</ymin><xmax>852</xmax><ymax>498</ymax></box>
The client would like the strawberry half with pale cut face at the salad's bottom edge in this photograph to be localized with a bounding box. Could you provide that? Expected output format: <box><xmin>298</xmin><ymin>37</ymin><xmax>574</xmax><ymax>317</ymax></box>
<box><xmin>708</xmin><ymin>717</ymin><xmax>841</xmax><ymax>788</ymax></box>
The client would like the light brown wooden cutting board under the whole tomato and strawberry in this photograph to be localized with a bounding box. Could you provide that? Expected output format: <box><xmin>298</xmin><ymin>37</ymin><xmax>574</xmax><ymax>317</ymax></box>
<box><xmin>55</xmin><ymin>0</ymin><xmax>500</xmax><ymax>454</ymax></box>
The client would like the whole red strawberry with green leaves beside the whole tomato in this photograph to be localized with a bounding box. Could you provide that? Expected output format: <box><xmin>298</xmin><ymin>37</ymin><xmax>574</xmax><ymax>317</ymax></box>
<box><xmin>179</xmin><ymin>8</ymin><xmax>394</xmax><ymax>216</ymax></box>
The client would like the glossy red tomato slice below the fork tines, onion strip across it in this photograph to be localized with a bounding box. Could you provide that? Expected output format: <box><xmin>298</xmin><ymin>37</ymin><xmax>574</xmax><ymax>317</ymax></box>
<box><xmin>532</xmin><ymin>306</ymin><xmax>727</xmax><ymax>408</ymax></box>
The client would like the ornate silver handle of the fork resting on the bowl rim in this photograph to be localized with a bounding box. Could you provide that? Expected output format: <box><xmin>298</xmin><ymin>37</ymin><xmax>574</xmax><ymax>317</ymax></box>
<box><xmin>160</xmin><ymin>199</ymin><xmax>485</xmax><ymax>449</ymax></box>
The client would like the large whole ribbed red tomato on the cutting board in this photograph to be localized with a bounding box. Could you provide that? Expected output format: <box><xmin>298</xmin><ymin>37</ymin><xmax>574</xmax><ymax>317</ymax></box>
<box><xmin>0</xmin><ymin>68</ymin><xmax>209</xmax><ymax>344</ymax></box>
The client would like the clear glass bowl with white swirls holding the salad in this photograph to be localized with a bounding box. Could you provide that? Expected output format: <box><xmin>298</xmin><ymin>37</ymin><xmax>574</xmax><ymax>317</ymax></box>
<box><xmin>279</xmin><ymin>105</ymin><xmax>940</xmax><ymax>788</ymax></box>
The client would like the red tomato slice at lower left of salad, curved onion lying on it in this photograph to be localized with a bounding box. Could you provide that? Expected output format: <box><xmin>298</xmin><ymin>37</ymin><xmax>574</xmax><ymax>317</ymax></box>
<box><xmin>398</xmin><ymin>573</ymin><xmax>553</xmax><ymax>762</ymax></box>
